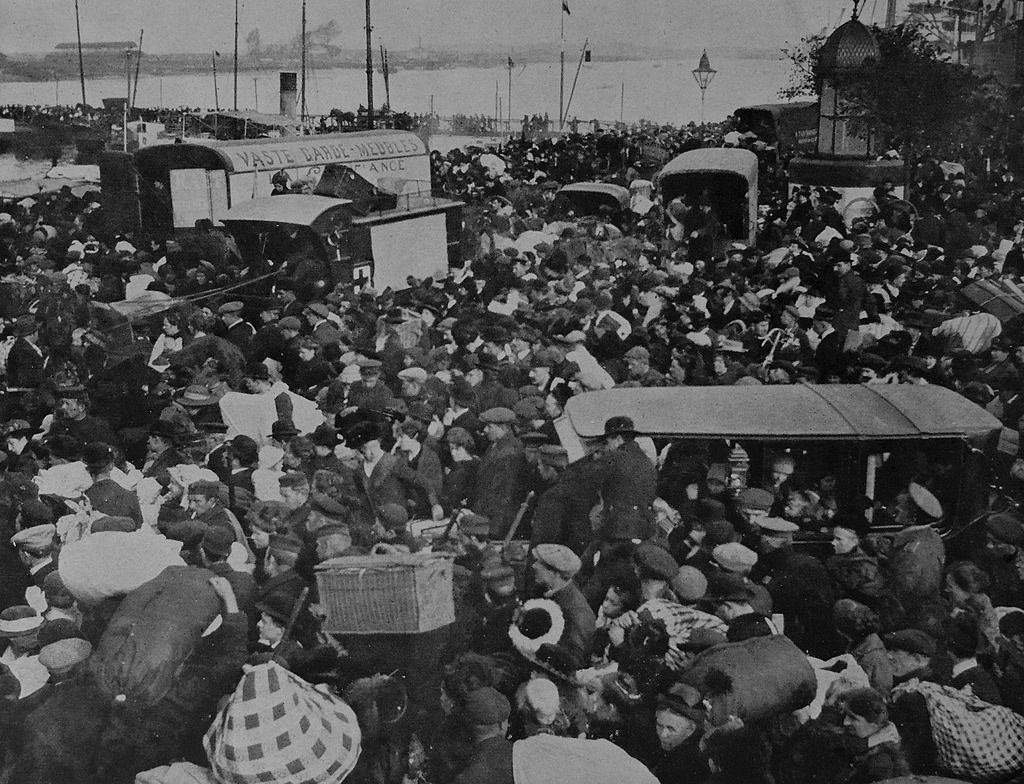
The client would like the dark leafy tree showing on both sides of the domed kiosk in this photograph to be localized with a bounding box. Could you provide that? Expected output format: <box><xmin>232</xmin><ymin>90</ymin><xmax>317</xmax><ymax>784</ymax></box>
<box><xmin>781</xmin><ymin>25</ymin><xmax>1008</xmax><ymax>187</ymax></box>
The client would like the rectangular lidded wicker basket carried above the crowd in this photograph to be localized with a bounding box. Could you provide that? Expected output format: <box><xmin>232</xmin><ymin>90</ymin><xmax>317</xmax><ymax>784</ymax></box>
<box><xmin>316</xmin><ymin>553</ymin><xmax>455</xmax><ymax>635</ymax></box>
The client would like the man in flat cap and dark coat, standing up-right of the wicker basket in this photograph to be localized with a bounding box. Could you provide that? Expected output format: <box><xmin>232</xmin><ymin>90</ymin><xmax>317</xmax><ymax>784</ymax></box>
<box><xmin>473</xmin><ymin>406</ymin><xmax>529</xmax><ymax>539</ymax></box>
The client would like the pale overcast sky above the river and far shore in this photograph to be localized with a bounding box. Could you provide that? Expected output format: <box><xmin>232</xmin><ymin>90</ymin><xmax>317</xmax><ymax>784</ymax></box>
<box><xmin>0</xmin><ymin>0</ymin><xmax>847</xmax><ymax>53</ymax></box>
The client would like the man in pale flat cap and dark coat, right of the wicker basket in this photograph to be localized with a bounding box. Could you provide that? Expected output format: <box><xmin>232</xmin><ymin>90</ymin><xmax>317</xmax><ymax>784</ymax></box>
<box><xmin>532</xmin><ymin>543</ymin><xmax>597</xmax><ymax>667</ymax></box>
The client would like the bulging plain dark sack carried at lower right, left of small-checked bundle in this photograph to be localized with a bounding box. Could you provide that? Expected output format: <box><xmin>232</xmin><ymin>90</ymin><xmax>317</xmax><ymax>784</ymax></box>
<box><xmin>680</xmin><ymin>635</ymin><xmax>817</xmax><ymax>722</ymax></box>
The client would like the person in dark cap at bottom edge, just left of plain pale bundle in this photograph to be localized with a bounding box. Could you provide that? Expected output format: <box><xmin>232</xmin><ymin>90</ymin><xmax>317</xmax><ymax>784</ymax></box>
<box><xmin>455</xmin><ymin>686</ymin><xmax>515</xmax><ymax>784</ymax></box>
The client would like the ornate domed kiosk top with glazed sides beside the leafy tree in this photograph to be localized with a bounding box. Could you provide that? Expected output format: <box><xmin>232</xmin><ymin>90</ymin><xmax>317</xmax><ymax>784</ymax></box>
<box><xmin>817</xmin><ymin>17</ymin><xmax>881</xmax><ymax>158</ymax></box>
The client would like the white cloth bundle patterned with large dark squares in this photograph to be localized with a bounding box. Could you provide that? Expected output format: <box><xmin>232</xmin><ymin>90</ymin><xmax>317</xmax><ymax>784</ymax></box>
<box><xmin>204</xmin><ymin>661</ymin><xmax>360</xmax><ymax>784</ymax></box>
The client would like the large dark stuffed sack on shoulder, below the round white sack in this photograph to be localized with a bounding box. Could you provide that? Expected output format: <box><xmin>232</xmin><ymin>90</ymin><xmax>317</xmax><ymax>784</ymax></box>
<box><xmin>89</xmin><ymin>566</ymin><xmax>220</xmax><ymax>705</ymax></box>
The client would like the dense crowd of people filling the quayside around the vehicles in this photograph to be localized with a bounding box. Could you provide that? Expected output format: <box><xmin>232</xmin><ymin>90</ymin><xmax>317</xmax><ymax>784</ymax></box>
<box><xmin>0</xmin><ymin>115</ymin><xmax>1024</xmax><ymax>784</ymax></box>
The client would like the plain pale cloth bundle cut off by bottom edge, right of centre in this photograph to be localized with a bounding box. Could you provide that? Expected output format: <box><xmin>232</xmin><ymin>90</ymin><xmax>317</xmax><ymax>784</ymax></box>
<box><xmin>512</xmin><ymin>735</ymin><xmax>657</xmax><ymax>784</ymax></box>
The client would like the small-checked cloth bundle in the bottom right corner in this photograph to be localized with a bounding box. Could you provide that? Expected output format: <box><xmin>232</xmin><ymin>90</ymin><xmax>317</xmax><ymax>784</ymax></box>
<box><xmin>893</xmin><ymin>680</ymin><xmax>1024</xmax><ymax>784</ymax></box>
